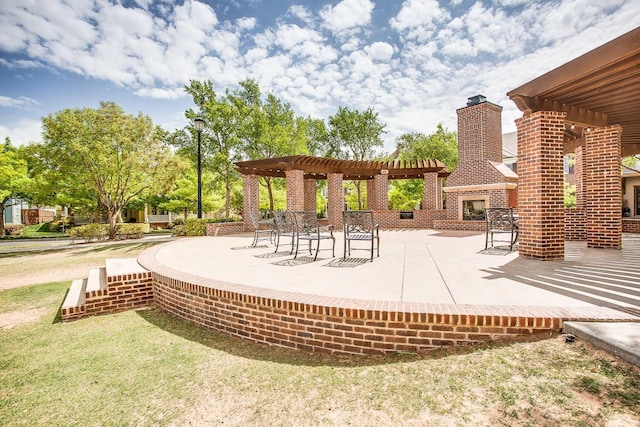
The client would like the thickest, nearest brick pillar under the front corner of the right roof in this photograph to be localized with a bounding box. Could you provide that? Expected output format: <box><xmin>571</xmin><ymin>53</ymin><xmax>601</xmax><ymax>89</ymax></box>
<box><xmin>516</xmin><ymin>111</ymin><xmax>566</xmax><ymax>260</ymax></box>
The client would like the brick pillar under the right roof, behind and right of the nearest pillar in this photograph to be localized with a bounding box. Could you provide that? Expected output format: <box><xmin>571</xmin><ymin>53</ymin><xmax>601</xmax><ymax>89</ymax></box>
<box><xmin>584</xmin><ymin>125</ymin><xmax>622</xmax><ymax>249</ymax></box>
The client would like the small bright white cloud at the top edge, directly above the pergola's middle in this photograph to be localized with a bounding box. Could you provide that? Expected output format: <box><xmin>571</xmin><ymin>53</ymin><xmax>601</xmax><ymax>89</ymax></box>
<box><xmin>320</xmin><ymin>0</ymin><xmax>374</xmax><ymax>35</ymax></box>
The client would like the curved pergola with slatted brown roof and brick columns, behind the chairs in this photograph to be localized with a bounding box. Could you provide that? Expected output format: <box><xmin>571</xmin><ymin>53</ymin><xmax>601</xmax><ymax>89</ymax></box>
<box><xmin>236</xmin><ymin>156</ymin><xmax>449</xmax><ymax>231</ymax></box>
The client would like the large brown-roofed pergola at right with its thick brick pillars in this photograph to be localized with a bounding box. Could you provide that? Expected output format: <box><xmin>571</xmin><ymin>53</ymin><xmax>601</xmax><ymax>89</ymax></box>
<box><xmin>507</xmin><ymin>28</ymin><xmax>640</xmax><ymax>259</ymax></box>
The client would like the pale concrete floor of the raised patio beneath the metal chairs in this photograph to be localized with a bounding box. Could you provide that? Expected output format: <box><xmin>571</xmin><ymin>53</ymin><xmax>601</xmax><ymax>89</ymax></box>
<box><xmin>145</xmin><ymin>230</ymin><xmax>640</xmax><ymax>364</ymax></box>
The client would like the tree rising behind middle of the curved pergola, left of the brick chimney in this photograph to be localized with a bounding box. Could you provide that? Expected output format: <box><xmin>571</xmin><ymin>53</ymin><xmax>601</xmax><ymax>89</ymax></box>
<box><xmin>328</xmin><ymin>107</ymin><xmax>386</xmax><ymax>209</ymax></box>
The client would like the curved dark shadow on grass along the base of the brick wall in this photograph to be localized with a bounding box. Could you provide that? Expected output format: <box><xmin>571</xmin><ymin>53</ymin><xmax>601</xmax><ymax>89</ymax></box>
<box><xmin>136</xmin><ymin>308</ymin><xmax>557</xmax><ymax>367</ymax></box>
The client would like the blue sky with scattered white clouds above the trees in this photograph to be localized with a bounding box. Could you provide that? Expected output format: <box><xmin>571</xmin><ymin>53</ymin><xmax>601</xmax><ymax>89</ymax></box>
<box><xmin>0</xmin><ymin>0</ymin><xmax>640</xmax><ymax>152</ymax></box>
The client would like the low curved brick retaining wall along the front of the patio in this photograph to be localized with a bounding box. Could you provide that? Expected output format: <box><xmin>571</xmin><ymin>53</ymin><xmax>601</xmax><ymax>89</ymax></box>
<box><xmin>153</xmin><ymin>273</ymin><xmax>562</xmax><ymax>354</ymax></box>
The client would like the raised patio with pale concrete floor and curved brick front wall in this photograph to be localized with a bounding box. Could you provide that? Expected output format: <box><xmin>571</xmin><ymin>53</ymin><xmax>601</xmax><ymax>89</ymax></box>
<box><xmin>138</xmin><ymin>229</ymin><xmax>640</xmax><ymax>353</ymax></box>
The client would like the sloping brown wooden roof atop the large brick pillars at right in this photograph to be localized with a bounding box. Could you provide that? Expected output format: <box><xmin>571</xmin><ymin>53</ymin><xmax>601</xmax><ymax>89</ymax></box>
<box><xmin>507</xmin><ymin>27</ymin><xmax>640</xmax><ymax>156</ymax></box>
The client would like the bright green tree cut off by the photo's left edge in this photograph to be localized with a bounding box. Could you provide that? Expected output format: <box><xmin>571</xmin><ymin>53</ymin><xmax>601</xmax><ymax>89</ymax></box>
<box><xmin>0</xmin><ymin>137</ymin><xmax>29</xmax><ymax>237</ymax></box>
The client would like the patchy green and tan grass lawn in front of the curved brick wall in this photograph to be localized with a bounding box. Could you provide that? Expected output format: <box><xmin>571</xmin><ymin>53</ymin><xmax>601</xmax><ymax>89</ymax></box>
<box><xmin>0</xmin><ymin>242</ymin><xmax>640</xmax><ymax>426</ymax></box>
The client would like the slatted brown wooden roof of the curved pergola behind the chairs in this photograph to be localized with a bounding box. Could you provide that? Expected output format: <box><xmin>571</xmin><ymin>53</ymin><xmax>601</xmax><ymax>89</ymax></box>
<box><xmin>236</xmin><ymin>156</ymin><xmax>449</xmax><ymax>180</ymax></box>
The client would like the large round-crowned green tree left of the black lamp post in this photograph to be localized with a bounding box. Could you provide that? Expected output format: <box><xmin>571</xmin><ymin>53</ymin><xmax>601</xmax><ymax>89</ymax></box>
<box><xmin>38</xmin><ymin>102</ymin><xmax>180</xmax><ymax>239</ymax></box>
